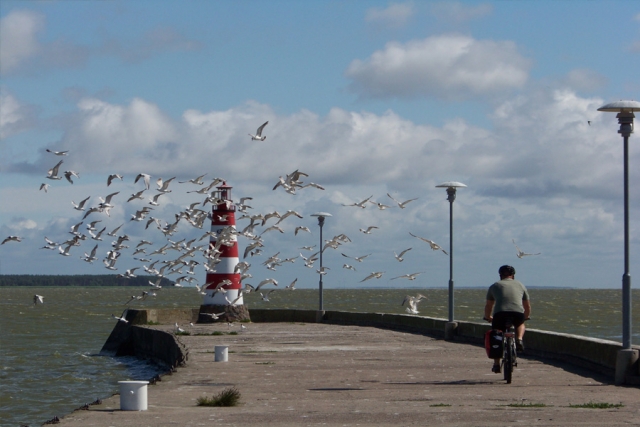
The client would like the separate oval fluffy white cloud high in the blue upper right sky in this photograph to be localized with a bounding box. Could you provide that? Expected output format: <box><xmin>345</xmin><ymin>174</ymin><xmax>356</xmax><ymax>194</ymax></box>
<box><xmin>346</xmin><ymin>35</ymin><xmax>530</xmax><ymax>99</ymax></box>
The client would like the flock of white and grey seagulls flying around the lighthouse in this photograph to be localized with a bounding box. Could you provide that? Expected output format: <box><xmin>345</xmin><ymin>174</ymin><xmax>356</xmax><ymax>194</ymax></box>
<box><xmin>1</xmin><ymin>121</ymin><xmax>539</xmax><ymax>321</ymax></box>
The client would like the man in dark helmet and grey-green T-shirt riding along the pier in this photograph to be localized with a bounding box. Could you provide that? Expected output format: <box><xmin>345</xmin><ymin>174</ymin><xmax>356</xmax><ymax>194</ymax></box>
<box><xmin>484</xmin><ymin>265</ymin><xmax>531</xmax><ymax>374</ymax></box>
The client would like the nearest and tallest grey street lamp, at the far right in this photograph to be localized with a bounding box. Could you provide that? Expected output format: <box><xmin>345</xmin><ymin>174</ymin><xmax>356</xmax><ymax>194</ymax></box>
<box><xmin>598</xmin><ymin>101</ymin><xmax>640</xmax><ymax>384</ymax></box>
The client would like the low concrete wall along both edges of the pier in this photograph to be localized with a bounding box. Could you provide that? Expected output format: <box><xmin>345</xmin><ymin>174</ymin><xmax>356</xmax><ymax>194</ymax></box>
<box><xmin>103</xmin><ymin>309</ymin><xmax>640</xmax><ymax>382</ymax></box>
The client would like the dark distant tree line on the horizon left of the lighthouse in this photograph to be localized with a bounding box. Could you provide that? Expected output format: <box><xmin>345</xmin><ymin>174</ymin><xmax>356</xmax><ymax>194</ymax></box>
<box><xmin>0</xmin><ymin>274</ymin><xmax>173</xmax><ymax>286</ymax></box>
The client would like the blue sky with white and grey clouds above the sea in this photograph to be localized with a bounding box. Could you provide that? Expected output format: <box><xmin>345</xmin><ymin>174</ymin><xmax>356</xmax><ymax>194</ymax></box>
<box><xmin>0</xmin><ymin>0</ymin><xmax>640</xmax><ymax>288</ymax></box>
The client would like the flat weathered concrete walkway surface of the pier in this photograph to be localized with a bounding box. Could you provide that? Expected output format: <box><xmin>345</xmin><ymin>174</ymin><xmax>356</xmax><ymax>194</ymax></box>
<box><xmin>59</xmin><ymin>323</ymin><xmax>640</xmax><ymax>427</ymax></box>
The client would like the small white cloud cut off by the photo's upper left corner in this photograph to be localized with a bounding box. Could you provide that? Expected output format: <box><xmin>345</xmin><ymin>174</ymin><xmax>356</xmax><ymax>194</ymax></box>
<box><xmin>0</xmin><ymin>10</ymin><xmax>44</xmax><ymax>74</ymax></box>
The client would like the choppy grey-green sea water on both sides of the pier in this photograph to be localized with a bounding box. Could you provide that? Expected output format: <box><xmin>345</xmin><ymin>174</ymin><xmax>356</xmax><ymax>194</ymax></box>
<box><xmin>0</xmin><ymin>287</ymin><xmax>640</xmax><ymax>427</ymax></box>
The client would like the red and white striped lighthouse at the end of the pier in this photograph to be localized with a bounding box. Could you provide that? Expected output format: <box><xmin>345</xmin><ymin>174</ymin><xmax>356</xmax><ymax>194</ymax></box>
<box><xmin>202</xmin><ymin>182</ymin><xmax>244</xmax><ymax>306</ymax></box>
